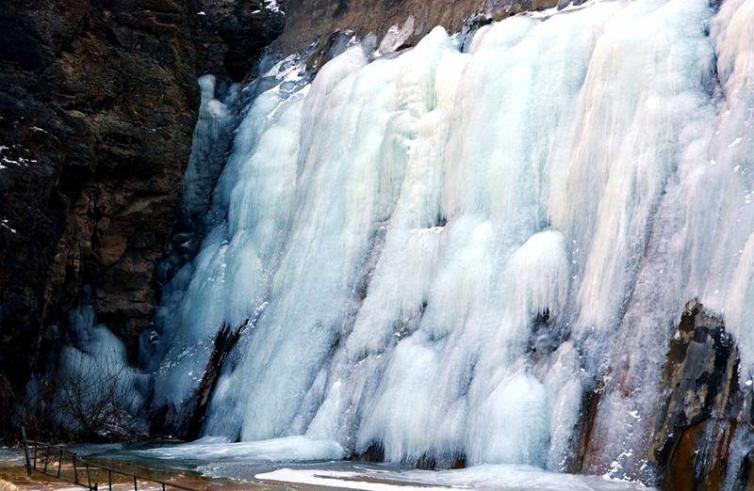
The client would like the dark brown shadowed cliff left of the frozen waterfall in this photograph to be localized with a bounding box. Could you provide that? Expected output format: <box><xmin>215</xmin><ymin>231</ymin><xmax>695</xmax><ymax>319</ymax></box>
<box><xmin>0</xmin><ymin>0</ymin><xmax>284</xmax><ymax>434</ymax></box>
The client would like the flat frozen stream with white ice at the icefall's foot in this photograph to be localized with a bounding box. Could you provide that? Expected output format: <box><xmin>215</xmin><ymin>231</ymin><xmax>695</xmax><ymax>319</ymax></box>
<box><xmin>67</xmin><ymin>437</ymin><xmax>647</xmax><ymax>491</ymax></box>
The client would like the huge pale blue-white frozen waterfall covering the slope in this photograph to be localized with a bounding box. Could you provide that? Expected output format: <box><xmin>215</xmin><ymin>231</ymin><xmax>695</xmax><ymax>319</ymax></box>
<box><xmin>151</xmin><ymin>0</ymin><xmax>754</xmax><ymax>475</ymax></box>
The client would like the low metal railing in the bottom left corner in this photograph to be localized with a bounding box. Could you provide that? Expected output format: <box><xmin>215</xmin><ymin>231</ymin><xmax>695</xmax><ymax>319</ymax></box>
<box><xmin>21</xmin><ymin>428</ymin><xmax>197</xmax><ymax>491</ymax></box>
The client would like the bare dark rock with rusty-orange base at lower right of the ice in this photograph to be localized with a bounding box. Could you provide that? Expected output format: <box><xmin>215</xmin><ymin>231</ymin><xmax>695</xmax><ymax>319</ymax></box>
<box><xmin>648</xmin><ymin>301</ymin><xmax>753</xmax><ymax>490</ymax></box>
